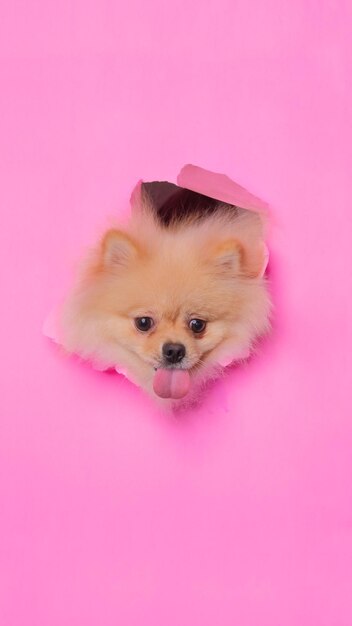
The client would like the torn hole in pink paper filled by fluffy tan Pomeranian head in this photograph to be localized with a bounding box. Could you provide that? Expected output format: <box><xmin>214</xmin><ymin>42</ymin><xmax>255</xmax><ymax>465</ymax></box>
<box><xmin>60</xmin><ymin>183</ymin><xmax>270</xmax><ymax>404</ymax></box>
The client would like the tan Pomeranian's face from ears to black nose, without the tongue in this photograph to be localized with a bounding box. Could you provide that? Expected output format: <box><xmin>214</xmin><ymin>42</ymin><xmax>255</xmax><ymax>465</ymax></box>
<box><xmin>97</xmin><ymin>231</ymin><xmax>252</xmax><ymax>370</ymax></box>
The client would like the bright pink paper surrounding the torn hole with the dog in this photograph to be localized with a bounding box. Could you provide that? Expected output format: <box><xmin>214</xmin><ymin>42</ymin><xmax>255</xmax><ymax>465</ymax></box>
<box><xmin>0</xmin><ymin>0</ymin><xmax>352</xmax><ymax>626</ymax></box>
